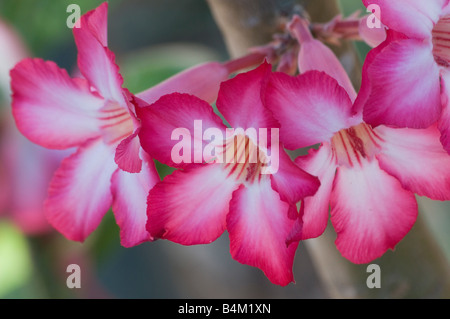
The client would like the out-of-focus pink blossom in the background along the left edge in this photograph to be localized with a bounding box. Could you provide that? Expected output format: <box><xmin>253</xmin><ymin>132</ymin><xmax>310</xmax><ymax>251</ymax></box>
<box><xmin>0</xmin><ymin>16</ymin><xmax>67</xmax><ymax>235</ymax></box>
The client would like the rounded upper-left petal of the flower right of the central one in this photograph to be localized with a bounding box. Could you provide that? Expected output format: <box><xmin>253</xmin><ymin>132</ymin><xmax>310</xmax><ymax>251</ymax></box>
<box><xmin>265</xmin><ymin>71</ymin><xmax>352</xmax><ymax>149</ymax></box>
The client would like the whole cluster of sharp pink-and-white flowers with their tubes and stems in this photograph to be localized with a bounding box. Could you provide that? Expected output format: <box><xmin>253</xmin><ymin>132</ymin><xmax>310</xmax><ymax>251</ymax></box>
<box><xmin>11</xmin><ymin>0</ymin><xmax>450</xmax><ymax>286</ymax></box>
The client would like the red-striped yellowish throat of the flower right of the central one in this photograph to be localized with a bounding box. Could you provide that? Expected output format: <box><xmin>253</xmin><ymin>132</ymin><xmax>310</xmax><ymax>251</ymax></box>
<box><xmin>331</xmin><ymin>123</ymin><xmax>381</xmax><ymax>167</ymax></box>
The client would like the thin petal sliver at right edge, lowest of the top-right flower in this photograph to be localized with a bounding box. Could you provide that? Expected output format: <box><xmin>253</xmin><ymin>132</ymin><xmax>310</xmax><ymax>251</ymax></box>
<box><xmin>438</xmin><ymin>69</ymin><xmax>450</xmax><ymax>154</ymax></box>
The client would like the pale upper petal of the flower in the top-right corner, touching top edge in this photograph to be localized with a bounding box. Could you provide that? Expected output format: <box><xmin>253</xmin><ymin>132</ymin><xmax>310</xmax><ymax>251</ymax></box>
<box><xmin>363</xmin><ymin>0</ymin><xmax>442</xmax><ymax>39</ymax></box>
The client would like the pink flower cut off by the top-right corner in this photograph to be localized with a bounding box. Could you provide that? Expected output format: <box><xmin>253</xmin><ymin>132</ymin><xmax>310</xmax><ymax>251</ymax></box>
<box><xmin>356</xmin><ymin>0</ymin><xmax>450</xmax><ymax>152</ymax></box>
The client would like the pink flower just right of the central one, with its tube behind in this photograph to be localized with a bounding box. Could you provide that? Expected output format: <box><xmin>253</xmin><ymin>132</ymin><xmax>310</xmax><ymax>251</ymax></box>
<box><xmin>265</xmin><ymin>16</ymin><xmax>450</xmax><ymax>263</ymax></box>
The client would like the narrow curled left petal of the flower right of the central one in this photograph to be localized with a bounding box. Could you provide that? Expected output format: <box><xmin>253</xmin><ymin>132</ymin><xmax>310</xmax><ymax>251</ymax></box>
<box><xmin>295</xmin><ymin>143</ymin><xmax>337</xmax><ymax>239</ymax></box>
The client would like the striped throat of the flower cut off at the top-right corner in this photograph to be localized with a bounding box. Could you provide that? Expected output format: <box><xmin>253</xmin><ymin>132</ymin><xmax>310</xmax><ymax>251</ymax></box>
<box><xmin>432</xmin><ymin>15</ymin><xmax>450</xmax><ymax>67</ymax></box>
